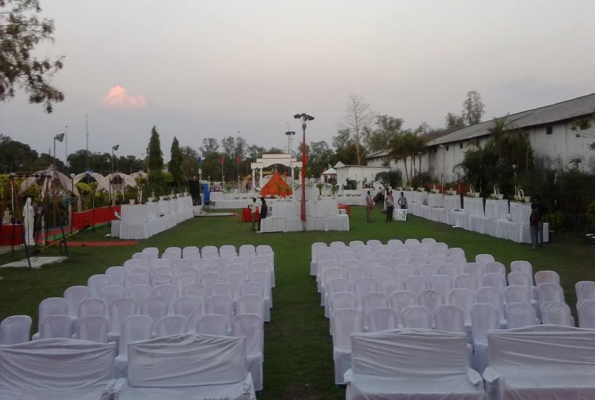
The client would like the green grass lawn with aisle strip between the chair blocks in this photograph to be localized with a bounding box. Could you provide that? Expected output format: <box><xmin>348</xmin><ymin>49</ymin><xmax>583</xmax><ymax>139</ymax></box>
<box><xmin>0</xmin><ymin>207</ymin><xmax>595</xmax><ymax>400</ymax></box>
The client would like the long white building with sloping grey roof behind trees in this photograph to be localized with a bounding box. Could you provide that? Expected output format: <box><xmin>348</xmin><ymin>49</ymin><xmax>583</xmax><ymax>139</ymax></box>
<box><xmin>366</xmin><ymin>93</ymin><xmax>595</xmax><ymax>182</ymax></box>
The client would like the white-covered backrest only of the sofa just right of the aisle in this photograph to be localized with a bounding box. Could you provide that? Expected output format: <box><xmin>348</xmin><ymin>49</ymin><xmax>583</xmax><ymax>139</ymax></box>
<box><xmin>351</xmin><ymin>329</ymin><xmax>469</xmax><ymax>381</ymax></box>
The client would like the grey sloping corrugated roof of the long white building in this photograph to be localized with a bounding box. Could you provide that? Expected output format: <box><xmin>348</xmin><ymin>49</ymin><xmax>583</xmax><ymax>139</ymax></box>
<box><xmin>428</xmin><ymin>93</ymin><xmax>595</xmax><ymax>146</ymax></box>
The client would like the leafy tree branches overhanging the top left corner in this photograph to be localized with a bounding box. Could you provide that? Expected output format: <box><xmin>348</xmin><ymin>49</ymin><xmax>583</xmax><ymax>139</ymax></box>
<box><xmin>0</xmin><ymin>0</ymin><xmax>64</xmax><ymax>113</ymax></box>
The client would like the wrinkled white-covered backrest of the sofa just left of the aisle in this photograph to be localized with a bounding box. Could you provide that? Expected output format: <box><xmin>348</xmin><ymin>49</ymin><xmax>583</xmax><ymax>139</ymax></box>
<box><xmin>128</xmin><ymin>334</ymin><xmax>247</xmax><ymax>387</ymax></box>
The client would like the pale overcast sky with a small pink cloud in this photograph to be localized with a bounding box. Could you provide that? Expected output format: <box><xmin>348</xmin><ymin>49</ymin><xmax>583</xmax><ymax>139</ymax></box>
<box><xmin>0</xmin><ymin>0</ymin><xmax>595</xmax><ymax>162</ymax></box>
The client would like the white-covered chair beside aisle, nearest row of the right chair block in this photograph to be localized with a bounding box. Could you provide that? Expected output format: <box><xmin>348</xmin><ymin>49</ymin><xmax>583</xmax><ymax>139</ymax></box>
<box><xmin>331</xmin><ymin>308</ymin><xmax>364</xmax><ymax>385</ymax></box>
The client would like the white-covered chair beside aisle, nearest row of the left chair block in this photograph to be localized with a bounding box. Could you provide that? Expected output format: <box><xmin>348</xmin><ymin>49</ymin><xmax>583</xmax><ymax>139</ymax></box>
<box><xmin>231</xmin><ymin>314</ymin><xmax>264</xmax><ymax>391</ymax></box>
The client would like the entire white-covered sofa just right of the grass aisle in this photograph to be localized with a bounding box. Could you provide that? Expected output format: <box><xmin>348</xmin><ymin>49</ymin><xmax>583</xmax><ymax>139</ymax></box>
<box><xmin>346</xmin><ymin>329</ymin><xmax>485</xmax><ymax>400</ymax></box>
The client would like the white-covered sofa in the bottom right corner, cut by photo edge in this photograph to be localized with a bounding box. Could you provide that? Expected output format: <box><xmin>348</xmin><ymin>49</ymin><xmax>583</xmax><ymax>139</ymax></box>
<box><xmin>484</xmin><ymin>325</ymin><xmax>595</xmax><ymax>400</ymax></box>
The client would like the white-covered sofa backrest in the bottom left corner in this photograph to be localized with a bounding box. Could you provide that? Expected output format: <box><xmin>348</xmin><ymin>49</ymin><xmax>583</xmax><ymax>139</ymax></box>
<box><xmin>0</xmin><ymin>339</ymin><xmax>116</xmax><ymax>392</ymax></box>
